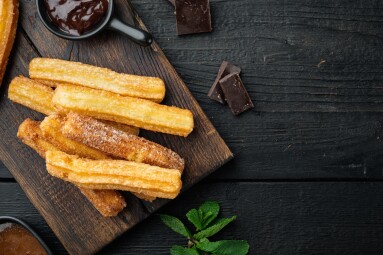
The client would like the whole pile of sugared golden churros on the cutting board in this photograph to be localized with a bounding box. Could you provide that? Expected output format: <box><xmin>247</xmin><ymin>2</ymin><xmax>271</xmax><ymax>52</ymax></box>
<box><xmin>8</xmin><ymin>58</ymin><xmax>194</xmax><ymax>217</ymax></box>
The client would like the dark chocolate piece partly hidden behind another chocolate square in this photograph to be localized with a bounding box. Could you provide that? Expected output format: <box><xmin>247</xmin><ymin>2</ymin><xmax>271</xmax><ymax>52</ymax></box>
<box><xmin>207</xmin><ymin>61</ymin><xmax>241</xmax><ymax>104</ymax></box>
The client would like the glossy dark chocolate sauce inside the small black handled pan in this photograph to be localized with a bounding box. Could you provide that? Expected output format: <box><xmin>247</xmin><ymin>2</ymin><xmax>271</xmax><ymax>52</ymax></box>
<box><xmin>44</xmin><ymin>0</ymin><xmax>109</xmax><ymax>35</ymax></box>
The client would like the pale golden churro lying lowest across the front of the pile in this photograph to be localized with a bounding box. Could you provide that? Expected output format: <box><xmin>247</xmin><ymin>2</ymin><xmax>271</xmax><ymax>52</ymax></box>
<box><xmin>46</xmin><ymin>151</ymin><xmax>182</xmax><ymax>198</ymax></box>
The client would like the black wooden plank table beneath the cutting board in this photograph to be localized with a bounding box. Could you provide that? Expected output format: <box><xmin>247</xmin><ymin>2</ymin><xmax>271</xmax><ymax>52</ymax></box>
<box><xmin>0</xmin><ymin>0</ymin><xmax>383</xmax><ymax>254</ymax></box>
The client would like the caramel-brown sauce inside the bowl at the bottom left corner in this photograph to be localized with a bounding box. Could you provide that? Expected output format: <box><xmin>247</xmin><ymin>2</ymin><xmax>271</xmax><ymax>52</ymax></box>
<box><xmin>0</xmin><ymin>222</ymin><xmax>47</xmax><ymax>255</ymax></box>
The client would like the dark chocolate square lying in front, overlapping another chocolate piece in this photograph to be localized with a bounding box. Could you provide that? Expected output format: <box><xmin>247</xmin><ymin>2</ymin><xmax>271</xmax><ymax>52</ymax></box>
<box><xmin>219</xmin><ymin>73</ymin><xmax>254</xmax><ymax>115</ymax></box>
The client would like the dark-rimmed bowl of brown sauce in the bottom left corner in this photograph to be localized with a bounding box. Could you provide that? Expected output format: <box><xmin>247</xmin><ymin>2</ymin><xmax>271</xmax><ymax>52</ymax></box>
<box><xmin>0</xmin><ymin>216</ymin><xmax>53</xmax><ymax>255</ymax></box>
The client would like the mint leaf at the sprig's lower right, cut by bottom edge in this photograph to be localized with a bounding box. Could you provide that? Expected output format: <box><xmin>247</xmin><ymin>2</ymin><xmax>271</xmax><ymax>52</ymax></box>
<box><xmin>197</xmin><ymin>240</ymin><xmax>249</xmax><ymax>255</ymax></box>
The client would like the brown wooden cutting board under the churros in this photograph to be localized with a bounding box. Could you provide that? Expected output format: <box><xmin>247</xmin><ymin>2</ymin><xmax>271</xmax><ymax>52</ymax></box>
<box><xmin>0</xmin><ymin>0</ymin><xmax>233</xmax><ymax>254</ymax></box>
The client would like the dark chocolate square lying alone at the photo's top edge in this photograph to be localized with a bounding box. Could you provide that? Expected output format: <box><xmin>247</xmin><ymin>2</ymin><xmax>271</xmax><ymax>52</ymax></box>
<box><xmin>175</xmin><ymin>0</ymin><xmax>212</xmax><ymax>35</ymax></box>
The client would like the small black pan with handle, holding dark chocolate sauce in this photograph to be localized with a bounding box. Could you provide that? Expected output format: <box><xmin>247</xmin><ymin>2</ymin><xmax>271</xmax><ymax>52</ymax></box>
<box><xmin>36</xmin><ymin>0</ymin><xmax>153</xmax><ymax>46</ymax></box>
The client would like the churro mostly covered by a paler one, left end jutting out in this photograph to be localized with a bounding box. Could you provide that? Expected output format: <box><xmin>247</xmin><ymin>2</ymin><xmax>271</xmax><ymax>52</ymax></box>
<box><xmin>8</xmin><ymin>76</ymin><xmax>140</xmax><ymax>135</ymax></box>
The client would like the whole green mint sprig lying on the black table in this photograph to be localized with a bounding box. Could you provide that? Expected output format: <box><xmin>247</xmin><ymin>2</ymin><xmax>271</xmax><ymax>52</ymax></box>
<box><xmin>160</xmin><ymin>201</ymin><xmax>249</xmax><ymax>255</ymax></box>
